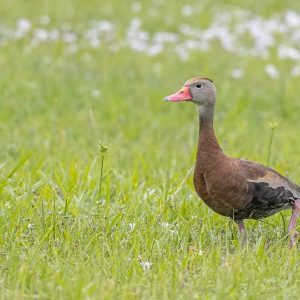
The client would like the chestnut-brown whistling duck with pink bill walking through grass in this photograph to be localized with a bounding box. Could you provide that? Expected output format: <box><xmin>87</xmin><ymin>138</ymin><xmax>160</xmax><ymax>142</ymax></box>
<box><xmin>164</xmin><ymin>78</ymin><xmax>300</xmax><ymax>247</ymax></box>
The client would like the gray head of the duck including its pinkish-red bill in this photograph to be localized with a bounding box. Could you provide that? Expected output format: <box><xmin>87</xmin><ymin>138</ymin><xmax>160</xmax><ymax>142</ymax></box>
<box><xmin>164</xmin><ymin>78</ymin><xmax>217</xmax><ymax>114</ymax></box>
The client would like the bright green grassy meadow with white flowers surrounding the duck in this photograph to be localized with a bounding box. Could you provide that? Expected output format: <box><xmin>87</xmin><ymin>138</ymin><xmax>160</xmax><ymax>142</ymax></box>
<box><xmin>0</xmin><ymin>0</ymin><xmax>300</xmax><ymax>299</ymax></box>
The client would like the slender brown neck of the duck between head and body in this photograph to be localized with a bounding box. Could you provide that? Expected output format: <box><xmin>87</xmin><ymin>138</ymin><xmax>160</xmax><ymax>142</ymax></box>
<box><xmin>196</xmin><ymin>108</ymin><xmax>224</xmax><ymax>165</ymax></box>
